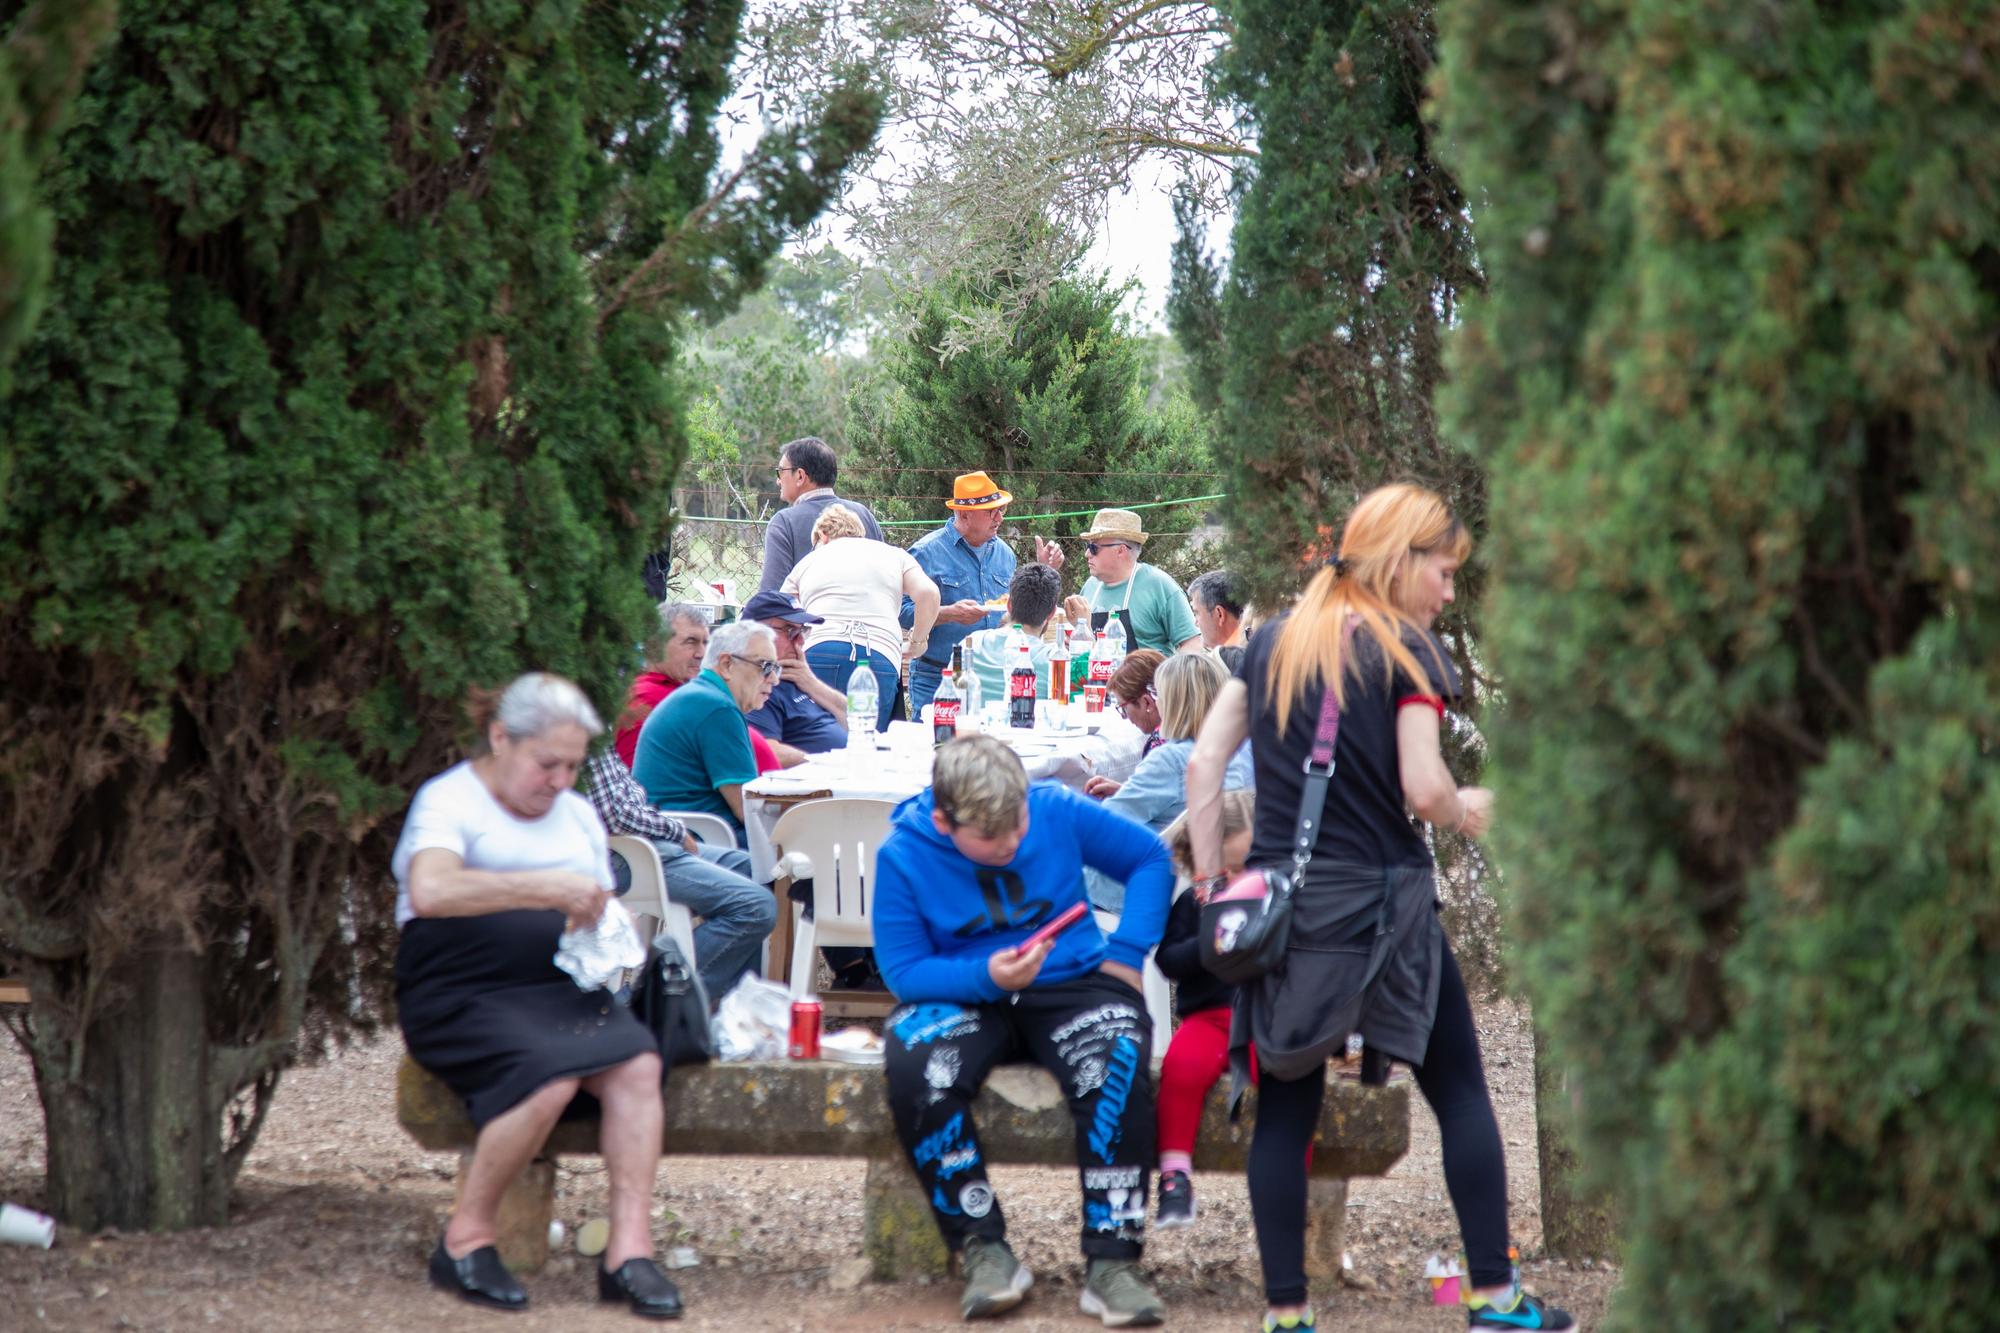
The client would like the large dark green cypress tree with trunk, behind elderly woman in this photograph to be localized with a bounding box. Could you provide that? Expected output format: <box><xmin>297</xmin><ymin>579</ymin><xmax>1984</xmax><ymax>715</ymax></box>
<box><xmin>0</xmin><ymin>0</ymin><xmax>878</xmax><ymax>1229</ymax></box>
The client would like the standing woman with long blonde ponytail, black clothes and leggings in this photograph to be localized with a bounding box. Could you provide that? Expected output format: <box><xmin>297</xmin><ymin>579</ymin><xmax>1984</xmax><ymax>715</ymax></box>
<box><xmin>1188</xmin><ymin>484</ymin><xmax>1574</xmax><ymax>1329</ymax></box>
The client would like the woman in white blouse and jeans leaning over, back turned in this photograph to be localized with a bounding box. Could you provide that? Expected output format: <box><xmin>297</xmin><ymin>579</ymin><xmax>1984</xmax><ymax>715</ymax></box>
<box><xmin>784</xmin><ymin>504</ymin><xmax>938</xmax><ymax>729</ymax></box>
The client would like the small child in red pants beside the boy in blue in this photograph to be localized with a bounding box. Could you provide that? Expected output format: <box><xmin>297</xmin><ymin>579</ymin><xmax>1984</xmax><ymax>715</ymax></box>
<box><xmin>1154</xmin><ymin>791</ymin><xmax>1256</xmax><ymax>1227</ymax></box>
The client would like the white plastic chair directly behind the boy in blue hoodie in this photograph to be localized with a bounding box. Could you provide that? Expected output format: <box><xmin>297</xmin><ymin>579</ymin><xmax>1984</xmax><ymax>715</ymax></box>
<box><xmin>770</xmin><ymin>799</ymin><xmax>896</xmax><ymax>1000</ymax></box>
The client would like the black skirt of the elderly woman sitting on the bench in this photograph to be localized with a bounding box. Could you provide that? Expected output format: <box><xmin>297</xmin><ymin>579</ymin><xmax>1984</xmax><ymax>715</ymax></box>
<box><xmin>396</xmin><ymin>911</ymin><xmax>658</xmax><ymax>1129</ymax></box>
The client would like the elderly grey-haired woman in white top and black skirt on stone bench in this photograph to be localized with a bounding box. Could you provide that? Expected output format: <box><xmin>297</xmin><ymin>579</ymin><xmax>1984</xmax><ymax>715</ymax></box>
<box><xmin>392</xmin><ymin>673</ymin><xmax>680</xmax><ymax>1319</ymax></box>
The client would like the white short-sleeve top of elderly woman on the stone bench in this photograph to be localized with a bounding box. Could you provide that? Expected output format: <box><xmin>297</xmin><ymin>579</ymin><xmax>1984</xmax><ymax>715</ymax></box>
<box><xmin>390</xmin><ymin>763</ymin><xmax>612</xmax><ymax>929</ymax></box>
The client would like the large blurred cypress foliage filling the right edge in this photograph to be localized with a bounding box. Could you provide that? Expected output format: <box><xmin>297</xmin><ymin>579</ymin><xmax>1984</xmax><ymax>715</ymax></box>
<box><xmin>1444</xmin><ymin>0</ymin><xmax>2000</xmax><ymax>1329</ymax></box>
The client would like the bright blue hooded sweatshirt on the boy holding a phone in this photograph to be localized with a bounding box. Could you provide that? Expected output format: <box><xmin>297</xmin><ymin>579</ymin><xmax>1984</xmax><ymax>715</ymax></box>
<box><xmin>872</xmin><ymin>783</ymin><xmax>1174</xmax><ymax>1005</ymax></box>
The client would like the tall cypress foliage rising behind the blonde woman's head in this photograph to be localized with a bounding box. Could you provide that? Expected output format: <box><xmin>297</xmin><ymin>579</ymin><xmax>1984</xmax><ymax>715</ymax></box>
<box><xmin>1170</xmin><ymin>0</ymin><xmax>1484</xmax><ymax>624</ymax></box>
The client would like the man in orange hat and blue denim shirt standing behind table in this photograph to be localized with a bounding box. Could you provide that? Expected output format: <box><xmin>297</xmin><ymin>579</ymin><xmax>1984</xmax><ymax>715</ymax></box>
<box><xmin>902</xmin><ymin>472</ymin><xmax>1062</xmax><ymax>709</ymax></box>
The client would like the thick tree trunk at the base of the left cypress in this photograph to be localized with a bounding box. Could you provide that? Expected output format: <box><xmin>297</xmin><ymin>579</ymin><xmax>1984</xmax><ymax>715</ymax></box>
<box><xmin>32</xmin><ymin>949</ymin><xmax>230</xmax><ymax>1231</ymax></box>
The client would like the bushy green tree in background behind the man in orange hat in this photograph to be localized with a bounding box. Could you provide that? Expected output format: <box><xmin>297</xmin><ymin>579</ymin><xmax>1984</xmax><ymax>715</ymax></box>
<box><xmin>854</xmin><ymin>266</ymin><xmax>1220</xmax><ymax>582</ymax></box>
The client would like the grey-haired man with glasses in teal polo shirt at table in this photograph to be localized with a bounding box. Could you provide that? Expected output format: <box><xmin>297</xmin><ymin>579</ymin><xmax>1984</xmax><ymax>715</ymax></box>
<box><xmin>632</xmin><ymin>620</ymin><xmax>784</xmax><ymax>839</ymax></box>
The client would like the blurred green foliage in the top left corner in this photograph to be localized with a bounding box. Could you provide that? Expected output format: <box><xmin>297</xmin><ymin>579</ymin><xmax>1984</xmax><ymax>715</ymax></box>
<box><xmin>0</xmin><ymin>0</ymin><xmax>116</xmax><ymax>392</ymax></box>
